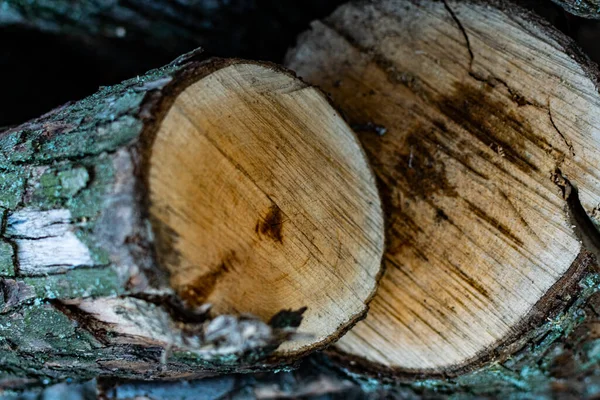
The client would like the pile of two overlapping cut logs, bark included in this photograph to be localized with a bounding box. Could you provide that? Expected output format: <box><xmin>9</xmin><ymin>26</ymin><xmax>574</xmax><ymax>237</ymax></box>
<box><xmin>0</xmin><ymin>0</ymin><xmax>600</xmax><ymax>398</ymax></box>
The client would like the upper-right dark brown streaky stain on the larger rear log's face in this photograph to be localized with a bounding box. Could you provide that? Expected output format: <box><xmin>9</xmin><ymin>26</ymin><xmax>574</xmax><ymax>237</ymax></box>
<box><xmin>437</xmin><ymin>82</ymin><xmax>551</xmax><ymax>174</ymax></box>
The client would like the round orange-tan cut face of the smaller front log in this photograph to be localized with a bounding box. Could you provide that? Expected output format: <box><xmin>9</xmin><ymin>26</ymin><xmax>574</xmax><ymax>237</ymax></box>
<box><xmin>149</xmin><ymin>63</ymin><xmax>383</xmax><ymax>353</ymax></box>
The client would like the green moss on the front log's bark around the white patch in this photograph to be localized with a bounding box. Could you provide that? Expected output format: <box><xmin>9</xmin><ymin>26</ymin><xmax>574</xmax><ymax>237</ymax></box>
<box><xmin>0</xmin><ymin>49</ymin><xmax>178</xmax><ymax>316</ymax></box>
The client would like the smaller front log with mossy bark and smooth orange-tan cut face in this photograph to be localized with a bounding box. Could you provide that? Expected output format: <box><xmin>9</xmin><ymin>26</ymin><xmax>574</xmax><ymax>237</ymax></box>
<box><xmin>0</xmin><ymin>53</ymin><xmax>383</xmax><ymax>378</ymax></box>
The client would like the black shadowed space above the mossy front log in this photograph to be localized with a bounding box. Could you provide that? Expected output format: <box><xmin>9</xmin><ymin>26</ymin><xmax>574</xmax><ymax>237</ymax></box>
<box><xmin>0</xmin><ymin>0</ymin><xmax>344</xmax><ymax>127</ymax></box>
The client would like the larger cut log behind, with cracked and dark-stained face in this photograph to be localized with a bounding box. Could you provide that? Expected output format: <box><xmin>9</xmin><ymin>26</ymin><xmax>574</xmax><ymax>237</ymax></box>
<box><xmin>287</xmin><ymin>0</ymin><xmax>600</xmax><ymax>382</ymax></box>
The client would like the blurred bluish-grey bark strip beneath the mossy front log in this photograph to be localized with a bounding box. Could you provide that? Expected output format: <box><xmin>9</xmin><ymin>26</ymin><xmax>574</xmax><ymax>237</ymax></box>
<box><xmin>2</xmin><ymin>363</ymin><xmax>366</xmax><ymax>400</ymax></box>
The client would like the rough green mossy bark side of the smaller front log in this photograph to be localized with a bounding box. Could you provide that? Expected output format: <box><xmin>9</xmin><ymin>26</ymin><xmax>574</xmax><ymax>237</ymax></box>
<box><xmin>0</xmin><ymin>48</ymin><xmax>379</xmax><ymax>389</ymax></box>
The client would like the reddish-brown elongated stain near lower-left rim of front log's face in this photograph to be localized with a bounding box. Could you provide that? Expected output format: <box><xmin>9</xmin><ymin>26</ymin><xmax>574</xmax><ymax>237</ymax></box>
<box><xmin>179</xmin><ymin>251</ymin><xmax>236</xmax><ymax>307</ymax></box>
